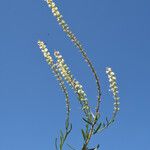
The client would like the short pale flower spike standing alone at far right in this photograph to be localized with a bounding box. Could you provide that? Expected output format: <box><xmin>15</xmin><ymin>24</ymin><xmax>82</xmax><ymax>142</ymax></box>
<box><xmin>106</xmin><ymin>67</ymin><xmax>119</xmax><ymax>113</ymax></box>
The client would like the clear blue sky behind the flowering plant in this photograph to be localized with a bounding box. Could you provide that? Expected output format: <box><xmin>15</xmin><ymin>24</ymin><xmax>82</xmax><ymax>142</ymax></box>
<box><xmin>0</xmin><ymin>0</ymin><xmax>150</xmax><ymax>150</ymax></box>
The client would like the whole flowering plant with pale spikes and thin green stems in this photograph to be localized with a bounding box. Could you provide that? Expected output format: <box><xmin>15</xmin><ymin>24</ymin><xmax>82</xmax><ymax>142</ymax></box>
<box><xmin>38</xmin><ymin>0</ymin><xmax>119</xmax><ymax>150</ymax></box>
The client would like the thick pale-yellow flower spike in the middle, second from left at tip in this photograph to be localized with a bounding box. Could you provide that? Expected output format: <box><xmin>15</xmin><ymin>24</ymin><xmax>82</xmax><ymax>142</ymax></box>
<box><xmin>54</xmin><ymin>51</ymin><xmax>90</xmax><ymax>114</ymax></box>
